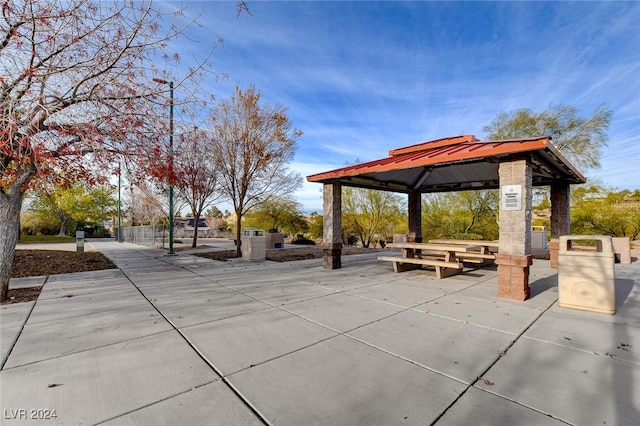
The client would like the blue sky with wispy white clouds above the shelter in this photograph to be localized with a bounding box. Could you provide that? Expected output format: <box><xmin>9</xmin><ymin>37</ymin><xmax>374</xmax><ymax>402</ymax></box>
<box><xmin>163</xmin><ymin>1</ymin><xmax>640</xmax><ymax>212</ymax></box>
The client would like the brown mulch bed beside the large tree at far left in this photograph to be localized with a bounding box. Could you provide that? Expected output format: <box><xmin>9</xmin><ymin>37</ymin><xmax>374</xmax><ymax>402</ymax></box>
<box><xmin>11</xmin><ymin>250</ymin><xmax>116</xmax><ymax>278</ymax></box>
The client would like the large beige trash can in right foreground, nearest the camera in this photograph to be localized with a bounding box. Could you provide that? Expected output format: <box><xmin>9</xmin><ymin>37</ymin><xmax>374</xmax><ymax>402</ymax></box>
<box><xmin>558</xmin><ymin>235</ymin><xmax>616</xmax><ymax>314</ymax></box>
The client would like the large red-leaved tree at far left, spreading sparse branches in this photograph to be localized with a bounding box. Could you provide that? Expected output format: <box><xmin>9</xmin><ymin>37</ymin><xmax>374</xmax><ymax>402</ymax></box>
<box><xmin>0</xmin><ymin>0</ymin><xmax>224</xmax><ymax>300</ymax></box>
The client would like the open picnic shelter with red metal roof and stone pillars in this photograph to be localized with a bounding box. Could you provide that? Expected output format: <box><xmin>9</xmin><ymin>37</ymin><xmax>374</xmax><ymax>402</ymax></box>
<box><xmin>307</xmin><ymin>135</ymin><xmax>586</xmax><ymax>300</ymax></box>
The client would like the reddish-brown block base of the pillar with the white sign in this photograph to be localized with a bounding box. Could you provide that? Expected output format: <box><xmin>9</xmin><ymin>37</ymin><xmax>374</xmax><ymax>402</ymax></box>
<box><xmin>496</xmin><ymin>253</ymin><xmax>533</xmax><ymax>301</ymax></box>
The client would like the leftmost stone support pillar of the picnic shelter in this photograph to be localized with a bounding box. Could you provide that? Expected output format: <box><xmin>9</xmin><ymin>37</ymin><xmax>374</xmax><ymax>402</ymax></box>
<box><xmin>322</xmin><ymin>183</ymin><xmax>342</xmax><ymax>269</ymax></box>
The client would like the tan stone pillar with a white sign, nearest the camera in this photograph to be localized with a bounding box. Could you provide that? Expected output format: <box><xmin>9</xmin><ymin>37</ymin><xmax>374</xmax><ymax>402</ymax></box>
<box><xmin>496</xmin><ymin>159</ymin><xmax>533</xmax><ymax>300</ymax></box>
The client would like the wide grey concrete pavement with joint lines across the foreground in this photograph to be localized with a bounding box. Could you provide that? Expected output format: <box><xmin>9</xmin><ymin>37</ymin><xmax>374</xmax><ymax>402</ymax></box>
<box><xmin>0</xmin><ymin>242</ymin><xmax>640</xmax><ymax>425</ymax></box>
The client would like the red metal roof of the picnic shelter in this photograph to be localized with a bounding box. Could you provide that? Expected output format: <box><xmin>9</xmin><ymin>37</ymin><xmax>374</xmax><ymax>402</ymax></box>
<box><xmin>307</xmin><ymin>135</ymin><xmax>586</xmax><ymax>193</ymax></box>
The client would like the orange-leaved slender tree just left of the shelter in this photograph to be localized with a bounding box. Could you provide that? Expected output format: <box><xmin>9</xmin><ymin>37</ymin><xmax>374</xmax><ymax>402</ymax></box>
<box><xmin>211</xmin><ymin>86</ymin><xmax>302</xmax><ymax>256</ymax></box>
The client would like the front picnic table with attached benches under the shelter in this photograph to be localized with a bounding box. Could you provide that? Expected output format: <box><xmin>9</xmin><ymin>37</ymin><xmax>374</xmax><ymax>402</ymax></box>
<box><xmin>378</xmin><ymin>242</ymin><xmax>492</xmax><ymax>279</ymax></box>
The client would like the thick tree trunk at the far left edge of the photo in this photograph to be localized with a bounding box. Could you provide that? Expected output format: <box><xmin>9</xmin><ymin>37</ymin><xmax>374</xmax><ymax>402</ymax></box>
<box><xmin>0</xmin><ymin>192</ymin><xmax>23</xmax><ymax>301</ymax></box>
